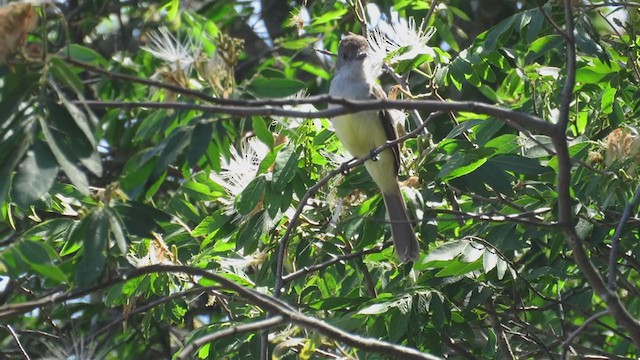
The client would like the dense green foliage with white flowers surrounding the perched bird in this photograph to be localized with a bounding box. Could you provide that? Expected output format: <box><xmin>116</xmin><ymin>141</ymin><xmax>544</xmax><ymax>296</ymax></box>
<box><xmin>0</xmin><ymin>0</ymin><xmax>640</xmax><ymax>359</ymax></box>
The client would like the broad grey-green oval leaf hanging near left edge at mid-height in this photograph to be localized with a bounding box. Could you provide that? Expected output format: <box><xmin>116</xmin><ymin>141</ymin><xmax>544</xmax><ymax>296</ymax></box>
<box><xmin>11</xmin><ymin>141</ymin><xmax>59</xmax><ymax>208</ymax></box>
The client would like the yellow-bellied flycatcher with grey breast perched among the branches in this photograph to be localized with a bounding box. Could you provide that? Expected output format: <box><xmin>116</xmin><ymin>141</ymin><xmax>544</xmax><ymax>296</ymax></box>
<box><xmin>329</xmin><ymin>35</ymin><xmax>420</xmax><ymax>262</ymax></box>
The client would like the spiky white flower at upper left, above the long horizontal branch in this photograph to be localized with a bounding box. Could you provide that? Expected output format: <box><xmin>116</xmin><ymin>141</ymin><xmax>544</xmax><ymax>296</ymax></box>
<box><xmin>140</xmin><ymin>27</ymin><xmax>202</xmax><ymax>75</ymax></box>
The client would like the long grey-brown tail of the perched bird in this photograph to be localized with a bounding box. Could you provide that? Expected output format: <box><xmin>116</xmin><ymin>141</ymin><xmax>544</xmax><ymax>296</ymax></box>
<box><xmin>382</xmin><ymin>189</ymin><xmax>420</xmax><ymax>262</ymax></box>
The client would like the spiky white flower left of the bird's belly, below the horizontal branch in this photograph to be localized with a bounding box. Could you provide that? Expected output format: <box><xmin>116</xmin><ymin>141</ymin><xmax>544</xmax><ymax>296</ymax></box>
<box><xmin>210</xmin><ymin>137</ymin><xmax>269</xmax><ymax>199</ymax></box>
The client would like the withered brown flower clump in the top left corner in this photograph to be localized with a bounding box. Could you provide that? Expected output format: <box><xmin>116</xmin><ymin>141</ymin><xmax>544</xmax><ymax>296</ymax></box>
<box><xmin>0</xmin><ymin>3</ymin><xmax>38</xmax><ymax>64</ymax></box>
